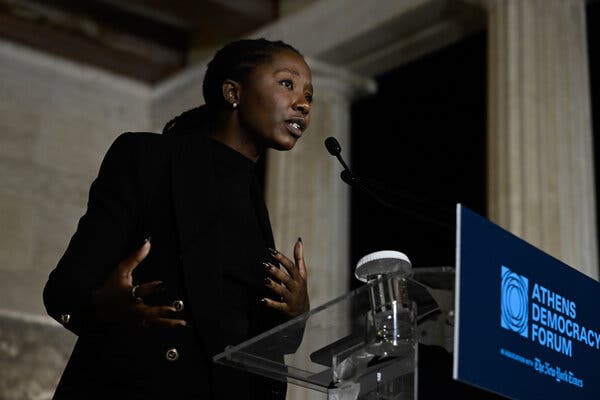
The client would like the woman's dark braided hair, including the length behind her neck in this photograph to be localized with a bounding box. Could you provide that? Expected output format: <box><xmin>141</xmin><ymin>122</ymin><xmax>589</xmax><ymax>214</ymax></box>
<box><xmin>163</xmin><ymin>38</ymin><xmax>303</xmax><ymax>133</ymax></box>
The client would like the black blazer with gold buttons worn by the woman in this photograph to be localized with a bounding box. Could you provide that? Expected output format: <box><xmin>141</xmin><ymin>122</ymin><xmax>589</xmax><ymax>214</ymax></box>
<box><xmin>44</xmin><ymin>115</ymin><xmax>285</xmax><ymax>399</ymax></box>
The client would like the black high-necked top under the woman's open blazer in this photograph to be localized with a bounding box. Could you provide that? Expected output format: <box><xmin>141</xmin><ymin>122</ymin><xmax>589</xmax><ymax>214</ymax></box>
<box><xmin>211</xmin><ymin>140</ymin><xmax>268</xmax><ymax>345</ymax></box>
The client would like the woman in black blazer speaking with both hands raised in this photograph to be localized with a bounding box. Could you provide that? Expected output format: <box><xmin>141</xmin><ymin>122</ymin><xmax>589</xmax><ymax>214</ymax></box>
<box><xmin>44</xmin><ymin>39</ymin><xmax>313</xmax><ymax>400</ymax></box>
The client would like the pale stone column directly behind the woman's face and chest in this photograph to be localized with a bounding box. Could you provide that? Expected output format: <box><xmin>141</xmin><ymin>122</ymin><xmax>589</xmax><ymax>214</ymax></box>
<box><xmin>265</xmin><ymin>60</ymin><xmax>375</xmax><ymax>400</ymax></box>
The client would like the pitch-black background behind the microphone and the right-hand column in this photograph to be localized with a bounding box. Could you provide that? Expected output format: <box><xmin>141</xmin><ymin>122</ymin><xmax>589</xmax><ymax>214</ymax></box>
<box><xmin>350</xmin><ymin>2</ymin><xmax>600</xmax><ymax>288</ymax></box>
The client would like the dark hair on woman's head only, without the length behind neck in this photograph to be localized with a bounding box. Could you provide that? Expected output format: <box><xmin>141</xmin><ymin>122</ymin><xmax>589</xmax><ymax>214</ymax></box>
<box><xmin>202</xmin><ymin>38</ymin><xmax>302</xmax><ymax>107</ymax></box>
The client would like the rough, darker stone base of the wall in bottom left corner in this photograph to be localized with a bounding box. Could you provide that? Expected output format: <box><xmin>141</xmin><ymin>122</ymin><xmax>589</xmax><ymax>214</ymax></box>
<box><xmin>0</xmin><ymin>313</ymin><xmax>76</xmax><ymax>400</ymax></box>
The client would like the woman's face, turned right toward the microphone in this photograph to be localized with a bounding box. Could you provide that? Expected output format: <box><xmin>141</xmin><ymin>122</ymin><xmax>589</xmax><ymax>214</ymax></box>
<box><xmin>237</xmin><ymin>50</ymin><xmax>313</xmax><ymax>150</ymax></box>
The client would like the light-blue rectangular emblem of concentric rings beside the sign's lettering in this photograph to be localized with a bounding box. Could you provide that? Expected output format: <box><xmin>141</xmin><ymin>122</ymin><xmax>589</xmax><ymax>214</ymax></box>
<box><xmin>500</xmin><ymin>267</ymin><xmax>529</xmax><ymax>337</ymax></box>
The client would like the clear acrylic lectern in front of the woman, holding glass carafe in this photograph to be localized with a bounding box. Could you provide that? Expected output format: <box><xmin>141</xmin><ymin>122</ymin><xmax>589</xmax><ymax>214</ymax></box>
<box><xmin>214</xmin><ymin>255</ymin><xmax>454</xmax><ymax>400</ymax></box>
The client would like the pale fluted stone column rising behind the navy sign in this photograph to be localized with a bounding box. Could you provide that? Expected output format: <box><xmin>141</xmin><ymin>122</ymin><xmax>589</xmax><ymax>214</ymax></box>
<box><xmin>485</xmin><ymin>0</ymin><xmax>598</xmax><ymax>278</ymax></box>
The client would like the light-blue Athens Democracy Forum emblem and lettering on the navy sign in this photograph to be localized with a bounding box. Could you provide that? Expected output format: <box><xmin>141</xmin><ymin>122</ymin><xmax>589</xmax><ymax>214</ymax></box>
<box><xmin>500</xmin><ymin>265</ymin><xmax>600</xmax><ymax>357</ymax></box>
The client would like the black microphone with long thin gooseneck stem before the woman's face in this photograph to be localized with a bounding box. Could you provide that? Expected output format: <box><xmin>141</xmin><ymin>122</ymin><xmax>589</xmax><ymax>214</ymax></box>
<box><xmin>325</xmin><ymin>136</ymin><xmax>454</xmax><ymax>230</ymax></box>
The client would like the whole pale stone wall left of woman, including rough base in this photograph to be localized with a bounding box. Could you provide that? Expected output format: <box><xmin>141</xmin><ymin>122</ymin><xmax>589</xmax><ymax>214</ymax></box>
<box><xmin>0</xmin><ymin>36</ymin><xmax>204</xmax><ymax>400</ymax></box>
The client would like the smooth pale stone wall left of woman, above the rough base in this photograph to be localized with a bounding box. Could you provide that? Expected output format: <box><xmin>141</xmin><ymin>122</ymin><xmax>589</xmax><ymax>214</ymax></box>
<box><xmin>0</xmin><ymin>42</ymin><xmax>149</xmax><ymax>314</ymax></box>
